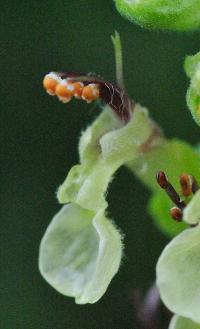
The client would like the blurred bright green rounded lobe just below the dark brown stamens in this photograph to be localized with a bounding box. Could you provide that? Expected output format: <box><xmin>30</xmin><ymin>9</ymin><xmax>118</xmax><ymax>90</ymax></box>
<box><xmin>148</xmin><ymin>191</ymin><xmax>188</xmax><ymax>237</ymax></box>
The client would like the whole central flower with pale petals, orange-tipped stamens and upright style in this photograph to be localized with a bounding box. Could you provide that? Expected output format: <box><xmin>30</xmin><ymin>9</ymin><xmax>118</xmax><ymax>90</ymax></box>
<box><xmin>39</xmin><ymin>34</ymin><xmax>158</xmax><ymax>304</ymax></box>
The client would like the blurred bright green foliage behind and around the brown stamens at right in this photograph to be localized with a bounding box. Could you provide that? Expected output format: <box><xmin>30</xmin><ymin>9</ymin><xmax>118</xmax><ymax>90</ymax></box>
<box><xmin>131</xmin><ymin>140</ymin><xmax>200</xmax><ymax>237</ymax></box>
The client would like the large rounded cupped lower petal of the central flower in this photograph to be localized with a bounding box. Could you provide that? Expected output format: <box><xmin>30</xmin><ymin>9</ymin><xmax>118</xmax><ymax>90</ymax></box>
<box><xmin>39</xmin><ymin>204</ymin><xmax>122</xmax><ymax>304</ymax></box>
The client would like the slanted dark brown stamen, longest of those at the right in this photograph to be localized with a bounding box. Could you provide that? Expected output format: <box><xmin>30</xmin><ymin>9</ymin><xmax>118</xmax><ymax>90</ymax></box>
<box><xmin>156</xmin><ymin>171</ymin><xmax>186</xmax><ymax>209</ymax></box>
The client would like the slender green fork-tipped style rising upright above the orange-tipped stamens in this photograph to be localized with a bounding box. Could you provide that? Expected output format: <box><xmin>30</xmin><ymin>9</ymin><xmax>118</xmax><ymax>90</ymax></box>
<box><xmin>111</xmin><ymin>31</ymin><xmax>125</xmax><ymax>90</ymax></box>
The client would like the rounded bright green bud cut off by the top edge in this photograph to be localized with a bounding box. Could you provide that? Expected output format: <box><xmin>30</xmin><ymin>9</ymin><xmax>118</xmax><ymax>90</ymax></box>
<box><xmin>115</xmin><ymin>0</ymin><xmax>200</xmax><ymax>31</ymax></box>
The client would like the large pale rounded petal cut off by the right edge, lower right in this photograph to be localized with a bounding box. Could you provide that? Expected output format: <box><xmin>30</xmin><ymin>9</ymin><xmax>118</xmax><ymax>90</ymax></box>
<box><xmin>156</xmin><ymin>225</ymin><xmax>200</xmax><ymax>323</ymax></box>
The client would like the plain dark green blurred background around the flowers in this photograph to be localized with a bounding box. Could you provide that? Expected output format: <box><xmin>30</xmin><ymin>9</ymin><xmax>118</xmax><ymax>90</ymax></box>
<box><xmin>0</xmin><ymin>0</ymin><xmax>200</xmax><ymax>329</ymax></box>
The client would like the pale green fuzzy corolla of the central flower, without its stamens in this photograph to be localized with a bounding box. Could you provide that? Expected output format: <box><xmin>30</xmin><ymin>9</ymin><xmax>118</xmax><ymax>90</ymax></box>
<box><xmin>39</xmin><ymin>100</ymin><xmax>155</xmax><ymax>304</ymax></box>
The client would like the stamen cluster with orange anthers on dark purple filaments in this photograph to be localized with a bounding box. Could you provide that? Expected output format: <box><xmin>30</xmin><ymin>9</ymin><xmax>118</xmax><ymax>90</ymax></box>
<box><xmin>43</xmin><ymin>72</ymin><xmax>134</xmax><ymax>122</ymax></box>
